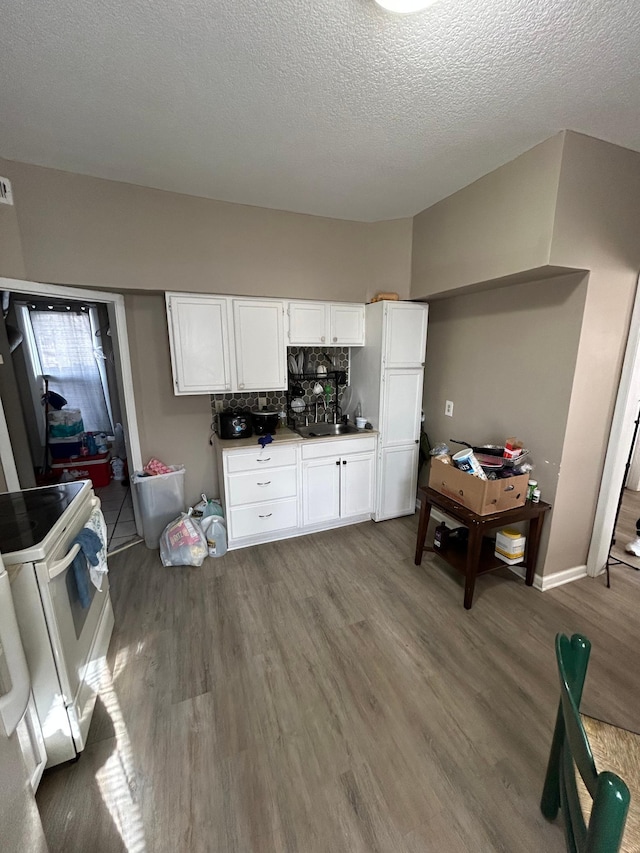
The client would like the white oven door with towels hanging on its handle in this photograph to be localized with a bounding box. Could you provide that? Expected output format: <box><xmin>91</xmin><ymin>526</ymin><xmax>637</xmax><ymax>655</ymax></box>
<box><xmin>35</xmin><ymin>497</ymin><xmax>113</xmax><ymax>752</ymax></box>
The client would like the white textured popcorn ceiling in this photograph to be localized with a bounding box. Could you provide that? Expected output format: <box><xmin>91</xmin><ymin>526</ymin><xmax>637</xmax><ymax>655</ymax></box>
<box><xmin>0</xmin><ymin>0</ymin><xmax>640</xmax><ymax>220</ymax></box>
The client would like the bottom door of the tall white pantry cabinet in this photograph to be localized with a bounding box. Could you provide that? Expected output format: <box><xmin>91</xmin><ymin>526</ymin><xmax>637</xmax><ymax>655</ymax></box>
<box><xmin>374</xmin><ymin>444</ymin><xmax>419</xmax><ymax>521</ymax></box>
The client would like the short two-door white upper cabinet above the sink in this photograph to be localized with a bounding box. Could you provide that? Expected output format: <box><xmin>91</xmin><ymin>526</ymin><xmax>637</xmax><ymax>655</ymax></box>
<box><xmin>289</xmin><ymin>301</ymin><xmax>364</xmax><ymax>347</ymax></box>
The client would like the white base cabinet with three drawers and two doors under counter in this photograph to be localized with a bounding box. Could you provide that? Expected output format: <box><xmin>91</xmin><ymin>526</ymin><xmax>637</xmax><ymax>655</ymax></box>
<box><xmin>216</xmin><ymin>436</ymin><xmax>377</xmax><ymax>549</ymax></box>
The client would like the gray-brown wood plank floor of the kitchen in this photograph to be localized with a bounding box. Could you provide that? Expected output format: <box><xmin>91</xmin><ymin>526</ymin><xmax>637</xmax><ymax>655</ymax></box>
<box><xmin>37</xmin><ymin>517</ymin><xmax>640</xmax><ymax>853</ymax></box>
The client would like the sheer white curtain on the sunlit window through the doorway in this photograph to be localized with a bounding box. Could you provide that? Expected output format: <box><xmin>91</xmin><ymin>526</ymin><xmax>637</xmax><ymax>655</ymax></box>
<box><xmin>29</xmin><ymin>310</ymin><xmax>113</xmax><ymax>434</ymax></box>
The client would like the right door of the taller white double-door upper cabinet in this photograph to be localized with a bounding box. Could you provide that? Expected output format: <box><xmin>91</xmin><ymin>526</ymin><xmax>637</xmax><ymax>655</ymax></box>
<box><xmin>233</xmin><ymin>299</ymin><xmax>287</xmax><ymax>391</ymax></box>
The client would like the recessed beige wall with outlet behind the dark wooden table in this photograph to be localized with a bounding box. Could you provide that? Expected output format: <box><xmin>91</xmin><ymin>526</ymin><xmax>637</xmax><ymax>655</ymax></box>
<box><xmin>423</xmin><ymin>273</ymin><xmax>587</xmax><ymax>566</ymax></box>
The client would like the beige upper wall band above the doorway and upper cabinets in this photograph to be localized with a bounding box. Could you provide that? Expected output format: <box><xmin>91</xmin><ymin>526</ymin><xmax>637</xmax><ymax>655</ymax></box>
<box><xmin>0</xmin><ymin>159</ymin><xmax>412</xmax><ymax>302</ymax></box>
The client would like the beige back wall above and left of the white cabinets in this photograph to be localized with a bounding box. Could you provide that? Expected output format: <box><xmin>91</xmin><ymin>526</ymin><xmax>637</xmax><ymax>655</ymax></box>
<box><xmin>0</xmin><ymin>159</ymin><xmax>413</xmax><ymax>499</ymax></box>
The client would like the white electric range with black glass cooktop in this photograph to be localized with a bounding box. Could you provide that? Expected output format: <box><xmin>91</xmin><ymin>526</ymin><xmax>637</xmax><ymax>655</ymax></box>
<box><xmin>0</xmin><ymin>480</ymin><xmax>113</xmax><ymax>767</ymax></box>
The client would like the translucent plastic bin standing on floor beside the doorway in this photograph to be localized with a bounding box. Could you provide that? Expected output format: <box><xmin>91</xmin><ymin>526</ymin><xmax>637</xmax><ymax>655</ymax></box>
<box><xmin>131</xmin><ymin>465</ymin><xmax>185</xmax><ymax>548</ymax></box>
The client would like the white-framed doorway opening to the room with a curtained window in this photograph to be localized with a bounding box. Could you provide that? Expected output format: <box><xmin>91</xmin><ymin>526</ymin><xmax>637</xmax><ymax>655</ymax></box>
<box><xmin>0</xmin><ymin>279</ymin><xmax>142</xmax><ymax>553</ymax></box>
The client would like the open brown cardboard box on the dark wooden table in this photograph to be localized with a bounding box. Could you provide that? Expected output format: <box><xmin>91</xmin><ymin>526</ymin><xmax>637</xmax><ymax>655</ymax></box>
<box><xmin>429</xmin><ymin>456</ymin><xmax>529</xmax><ymax>515</ymax></box>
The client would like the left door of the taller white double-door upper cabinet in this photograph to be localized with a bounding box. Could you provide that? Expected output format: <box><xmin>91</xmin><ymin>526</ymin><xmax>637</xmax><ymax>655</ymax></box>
<box><xmin>166</xmin><ymin>293</ymin><xmax>231</xmax><ymax>394</ymax></box>
